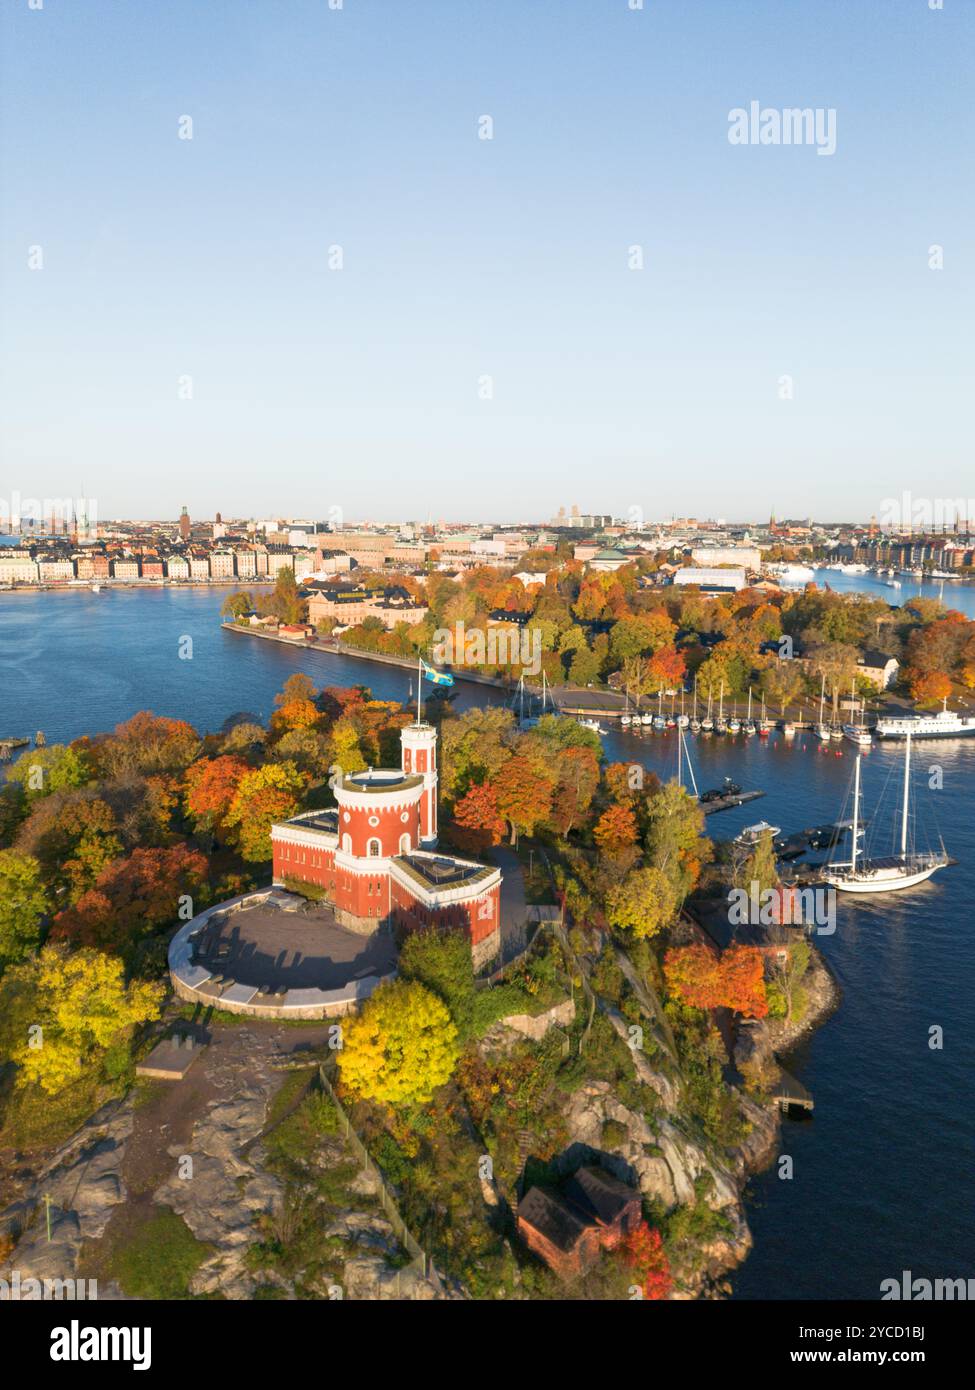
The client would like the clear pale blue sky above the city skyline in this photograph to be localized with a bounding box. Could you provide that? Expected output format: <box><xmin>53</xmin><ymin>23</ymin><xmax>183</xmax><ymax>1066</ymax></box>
<box><xmin>0</xmin><ymin>0</ymin><xmax>975</xmax><ymax>520</ymax></box>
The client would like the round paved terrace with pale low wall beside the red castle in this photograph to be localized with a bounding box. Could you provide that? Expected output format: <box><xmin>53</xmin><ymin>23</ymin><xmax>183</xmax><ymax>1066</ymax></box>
<box><xmin>170</xmin><ymin>888</ymin><xmax>396</xmax><ymax>1019</ymax></box>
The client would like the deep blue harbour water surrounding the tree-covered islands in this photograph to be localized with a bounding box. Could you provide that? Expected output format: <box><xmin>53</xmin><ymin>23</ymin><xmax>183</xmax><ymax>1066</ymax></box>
<box><xmin>0</xmin><ymin>583</ymin><xmax>975</xmax><ymax>1298</ymax></box>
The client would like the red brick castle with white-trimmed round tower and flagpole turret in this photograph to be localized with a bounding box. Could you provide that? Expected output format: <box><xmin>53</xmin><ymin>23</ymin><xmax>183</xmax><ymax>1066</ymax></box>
<box><xmin>271</xmin><ymin>723</ymin><xmax>501</xmax><ymax>969</ymax></box>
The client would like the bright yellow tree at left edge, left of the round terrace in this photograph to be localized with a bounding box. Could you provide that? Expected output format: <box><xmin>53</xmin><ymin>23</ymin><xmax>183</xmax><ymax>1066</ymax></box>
<box><xmin>0</xmin><ymin>947</ymin><xmax>166</xmax><ymax>1095</ymax></box>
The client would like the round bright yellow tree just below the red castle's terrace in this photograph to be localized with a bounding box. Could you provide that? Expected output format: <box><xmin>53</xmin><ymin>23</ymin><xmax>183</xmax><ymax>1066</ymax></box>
<box><xmin>338</xmin><ymin>980</ymin><xmax>460</xmax><ymax>1105</ymax></box>
